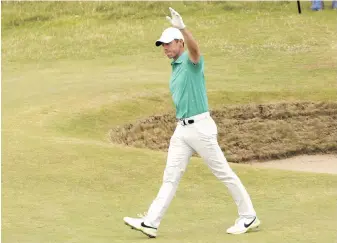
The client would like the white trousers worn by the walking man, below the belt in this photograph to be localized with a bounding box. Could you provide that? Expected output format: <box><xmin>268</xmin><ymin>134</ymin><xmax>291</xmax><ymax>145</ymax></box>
<box><xmin>145</xmin><ymin>112</ymin><xmax>256</xmax><ymax>228</ymax></box>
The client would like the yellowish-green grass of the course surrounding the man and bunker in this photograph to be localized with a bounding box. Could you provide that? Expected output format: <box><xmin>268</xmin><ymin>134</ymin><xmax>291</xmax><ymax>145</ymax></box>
<box><xmin>1</xmin><ymin>2</ymin><xmax>337</xmax><ymax>243</ymax></box>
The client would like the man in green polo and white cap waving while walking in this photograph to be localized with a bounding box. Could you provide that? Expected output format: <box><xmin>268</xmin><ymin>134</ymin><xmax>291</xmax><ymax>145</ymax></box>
<box><xmin>124</xmin><ymin>8</ymin><xmax>260</xmax><ymax>238</ymax></box>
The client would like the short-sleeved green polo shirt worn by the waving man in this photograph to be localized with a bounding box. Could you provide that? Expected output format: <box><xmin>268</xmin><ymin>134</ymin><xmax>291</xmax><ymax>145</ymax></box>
<box><xmin>170</xmin><ymin>51</ymin><xmax>208</xmax><ymax>119</ymax></box>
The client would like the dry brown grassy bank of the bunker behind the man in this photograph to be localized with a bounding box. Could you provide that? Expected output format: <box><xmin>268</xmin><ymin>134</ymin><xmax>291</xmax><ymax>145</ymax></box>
<box><xmin>110</xmin><ymin>102</ymin><xmax>337</xmax><ymax>162</ymax></box>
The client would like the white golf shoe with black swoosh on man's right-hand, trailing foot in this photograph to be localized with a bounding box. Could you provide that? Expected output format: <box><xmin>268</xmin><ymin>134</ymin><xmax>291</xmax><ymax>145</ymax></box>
<box><xmin>227</xmin><ymin>217</ymin><xmax>261</xmax><ymax>235</ymax></box>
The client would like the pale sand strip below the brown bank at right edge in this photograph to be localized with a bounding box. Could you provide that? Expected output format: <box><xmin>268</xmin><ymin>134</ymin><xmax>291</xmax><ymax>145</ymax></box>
<box><xmin>251</xmin><ymin>155</ymin><xmax>337</xmax><ymax>174</ymax></box>
